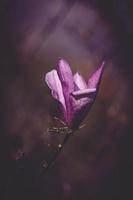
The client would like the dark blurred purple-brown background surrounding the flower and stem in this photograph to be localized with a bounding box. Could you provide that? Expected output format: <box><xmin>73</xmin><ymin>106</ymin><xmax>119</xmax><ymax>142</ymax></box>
<box><xmin>0</xmin><ymin>0</ymin><xmax>133</xmax><ymax>200</ymax></box>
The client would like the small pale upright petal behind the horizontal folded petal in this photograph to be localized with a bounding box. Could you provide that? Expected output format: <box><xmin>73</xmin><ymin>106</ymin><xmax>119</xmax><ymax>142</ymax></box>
<box><xmin>73</xmin><ymin>72</ymin><xmax>87</xmax><ymax>90</ymax></box>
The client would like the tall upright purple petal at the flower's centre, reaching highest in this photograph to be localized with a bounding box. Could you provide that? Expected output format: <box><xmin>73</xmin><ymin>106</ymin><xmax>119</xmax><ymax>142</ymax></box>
<box><xmin>57</xmin><ymin>59</ymin><xmax>74</xmax><ymax>123</ymax></box>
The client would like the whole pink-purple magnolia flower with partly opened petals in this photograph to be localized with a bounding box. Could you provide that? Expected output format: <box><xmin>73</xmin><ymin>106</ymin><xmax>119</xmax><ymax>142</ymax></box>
<box><xmin>45</xmin><ymin>59</ymin><xmax>104</xmax><ymax>130</ymax></box>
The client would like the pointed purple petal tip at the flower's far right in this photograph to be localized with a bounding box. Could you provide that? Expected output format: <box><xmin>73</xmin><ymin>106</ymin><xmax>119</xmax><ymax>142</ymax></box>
<box><xmin>88</xmin><ymin>62</ymin><xmax>105</xmax><ymax>88</ymax></box>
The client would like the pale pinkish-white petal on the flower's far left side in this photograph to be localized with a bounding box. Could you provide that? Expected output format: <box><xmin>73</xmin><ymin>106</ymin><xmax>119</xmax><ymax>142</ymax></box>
<box><xmin>45</xmin><ymin>70</ymin><xmax>66</xmax><ymax>111</ymax></box>
